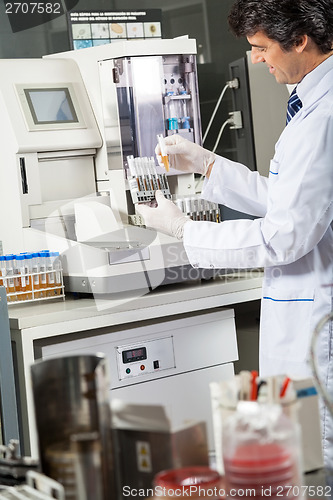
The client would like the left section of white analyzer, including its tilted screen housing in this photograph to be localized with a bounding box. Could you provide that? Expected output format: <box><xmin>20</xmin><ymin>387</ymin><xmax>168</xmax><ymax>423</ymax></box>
<box><xmin>0</xmin><ymin>59</ymin><xmax>102</xmax><ymax>254</ymax></box>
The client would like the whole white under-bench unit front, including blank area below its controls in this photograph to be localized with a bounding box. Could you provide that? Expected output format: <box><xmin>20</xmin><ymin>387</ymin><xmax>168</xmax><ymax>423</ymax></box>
<box><xmin>41</xmin><ymin>309</ymin><xmax>238</xmax><ymax>450</ymax></box>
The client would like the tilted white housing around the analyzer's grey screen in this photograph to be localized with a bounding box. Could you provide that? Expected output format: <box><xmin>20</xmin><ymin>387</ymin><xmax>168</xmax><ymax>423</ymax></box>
<box><xmin>0</xmin><ymin>59</ymin><xmax>102</xmax><ymax>153</ymax></box>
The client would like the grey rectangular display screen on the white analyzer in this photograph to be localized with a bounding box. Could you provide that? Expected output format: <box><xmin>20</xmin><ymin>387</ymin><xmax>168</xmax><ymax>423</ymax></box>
<box><xmin>24</xmin><ymin>87</ymin><xmax>79</xmax><ymax>125</ymax></box>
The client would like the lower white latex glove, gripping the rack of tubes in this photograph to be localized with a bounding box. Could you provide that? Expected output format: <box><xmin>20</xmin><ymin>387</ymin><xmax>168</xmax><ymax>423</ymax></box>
<box><xmin>136</xmin><ymin>191</ymin><xmax>191</xmax><ymax>240</ymax></box>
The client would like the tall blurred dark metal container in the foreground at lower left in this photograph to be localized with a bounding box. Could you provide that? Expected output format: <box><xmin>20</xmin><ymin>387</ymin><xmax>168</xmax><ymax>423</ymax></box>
<box><xmin>31</xmin><ymin>354</ymin><xmax>116</xmax><ymax>500</ymax></box>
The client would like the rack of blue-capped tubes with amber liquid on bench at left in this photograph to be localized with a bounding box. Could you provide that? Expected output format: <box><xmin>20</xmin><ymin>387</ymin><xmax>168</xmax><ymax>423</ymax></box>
<box><xmin>0</xmin><ymin>250</ymin><xmax>63</xmax><ymax>302</ymax></box>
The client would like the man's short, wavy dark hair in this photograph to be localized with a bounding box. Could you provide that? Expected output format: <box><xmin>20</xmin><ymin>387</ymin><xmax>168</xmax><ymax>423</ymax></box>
<box><xmin>228</xmin><ymin>0</ymin><xmax>333</xmax><ymax>54</ymax></box>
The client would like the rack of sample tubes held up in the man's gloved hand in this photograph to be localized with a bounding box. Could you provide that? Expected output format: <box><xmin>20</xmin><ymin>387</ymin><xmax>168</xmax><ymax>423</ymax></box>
<box><xmin>127</xmin><ymin>156</ymin><xmax>171</xmax><ymax>203</ymax></box>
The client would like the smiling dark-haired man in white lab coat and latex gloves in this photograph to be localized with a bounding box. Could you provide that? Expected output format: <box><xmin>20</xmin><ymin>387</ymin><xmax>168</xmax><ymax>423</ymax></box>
<box><xmin>139</xmin><ymin>0</ymin><xmax>333</xmax><ymax>468</ymax></box>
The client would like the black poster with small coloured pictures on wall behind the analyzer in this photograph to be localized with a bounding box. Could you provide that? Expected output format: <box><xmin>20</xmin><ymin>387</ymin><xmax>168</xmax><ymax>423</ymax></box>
<box><xmin>67</xmin><ymin>9</ymin><xmax>162</xmax><ymax>50</ymax></box>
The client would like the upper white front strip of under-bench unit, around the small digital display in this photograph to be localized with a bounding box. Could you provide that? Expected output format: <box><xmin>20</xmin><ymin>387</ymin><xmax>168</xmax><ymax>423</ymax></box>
<box><xmin>41</xmin><ymin>309</ymin><xmax>238</xmax><ymax>382</ymax></box>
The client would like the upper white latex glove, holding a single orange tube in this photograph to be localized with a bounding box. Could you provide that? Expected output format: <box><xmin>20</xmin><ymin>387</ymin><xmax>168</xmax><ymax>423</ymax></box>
<box><xmin>155</xmin><ymin>134</ymin><xmax>216</xmax><ymax>175</ymax></box>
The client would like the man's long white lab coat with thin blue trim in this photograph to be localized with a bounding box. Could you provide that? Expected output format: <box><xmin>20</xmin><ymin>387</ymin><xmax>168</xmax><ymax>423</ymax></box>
<box><xmin>184</xmin><ymin>57</ymin><xmax>333</xmax><ymax>468</ymax></box>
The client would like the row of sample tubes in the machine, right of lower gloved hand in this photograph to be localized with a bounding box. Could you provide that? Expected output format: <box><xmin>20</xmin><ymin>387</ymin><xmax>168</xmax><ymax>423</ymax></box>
<box><xmin>174</xmin><ymin>196</ymin><xmax>221</xmax><ymax>222</ymax></box>
